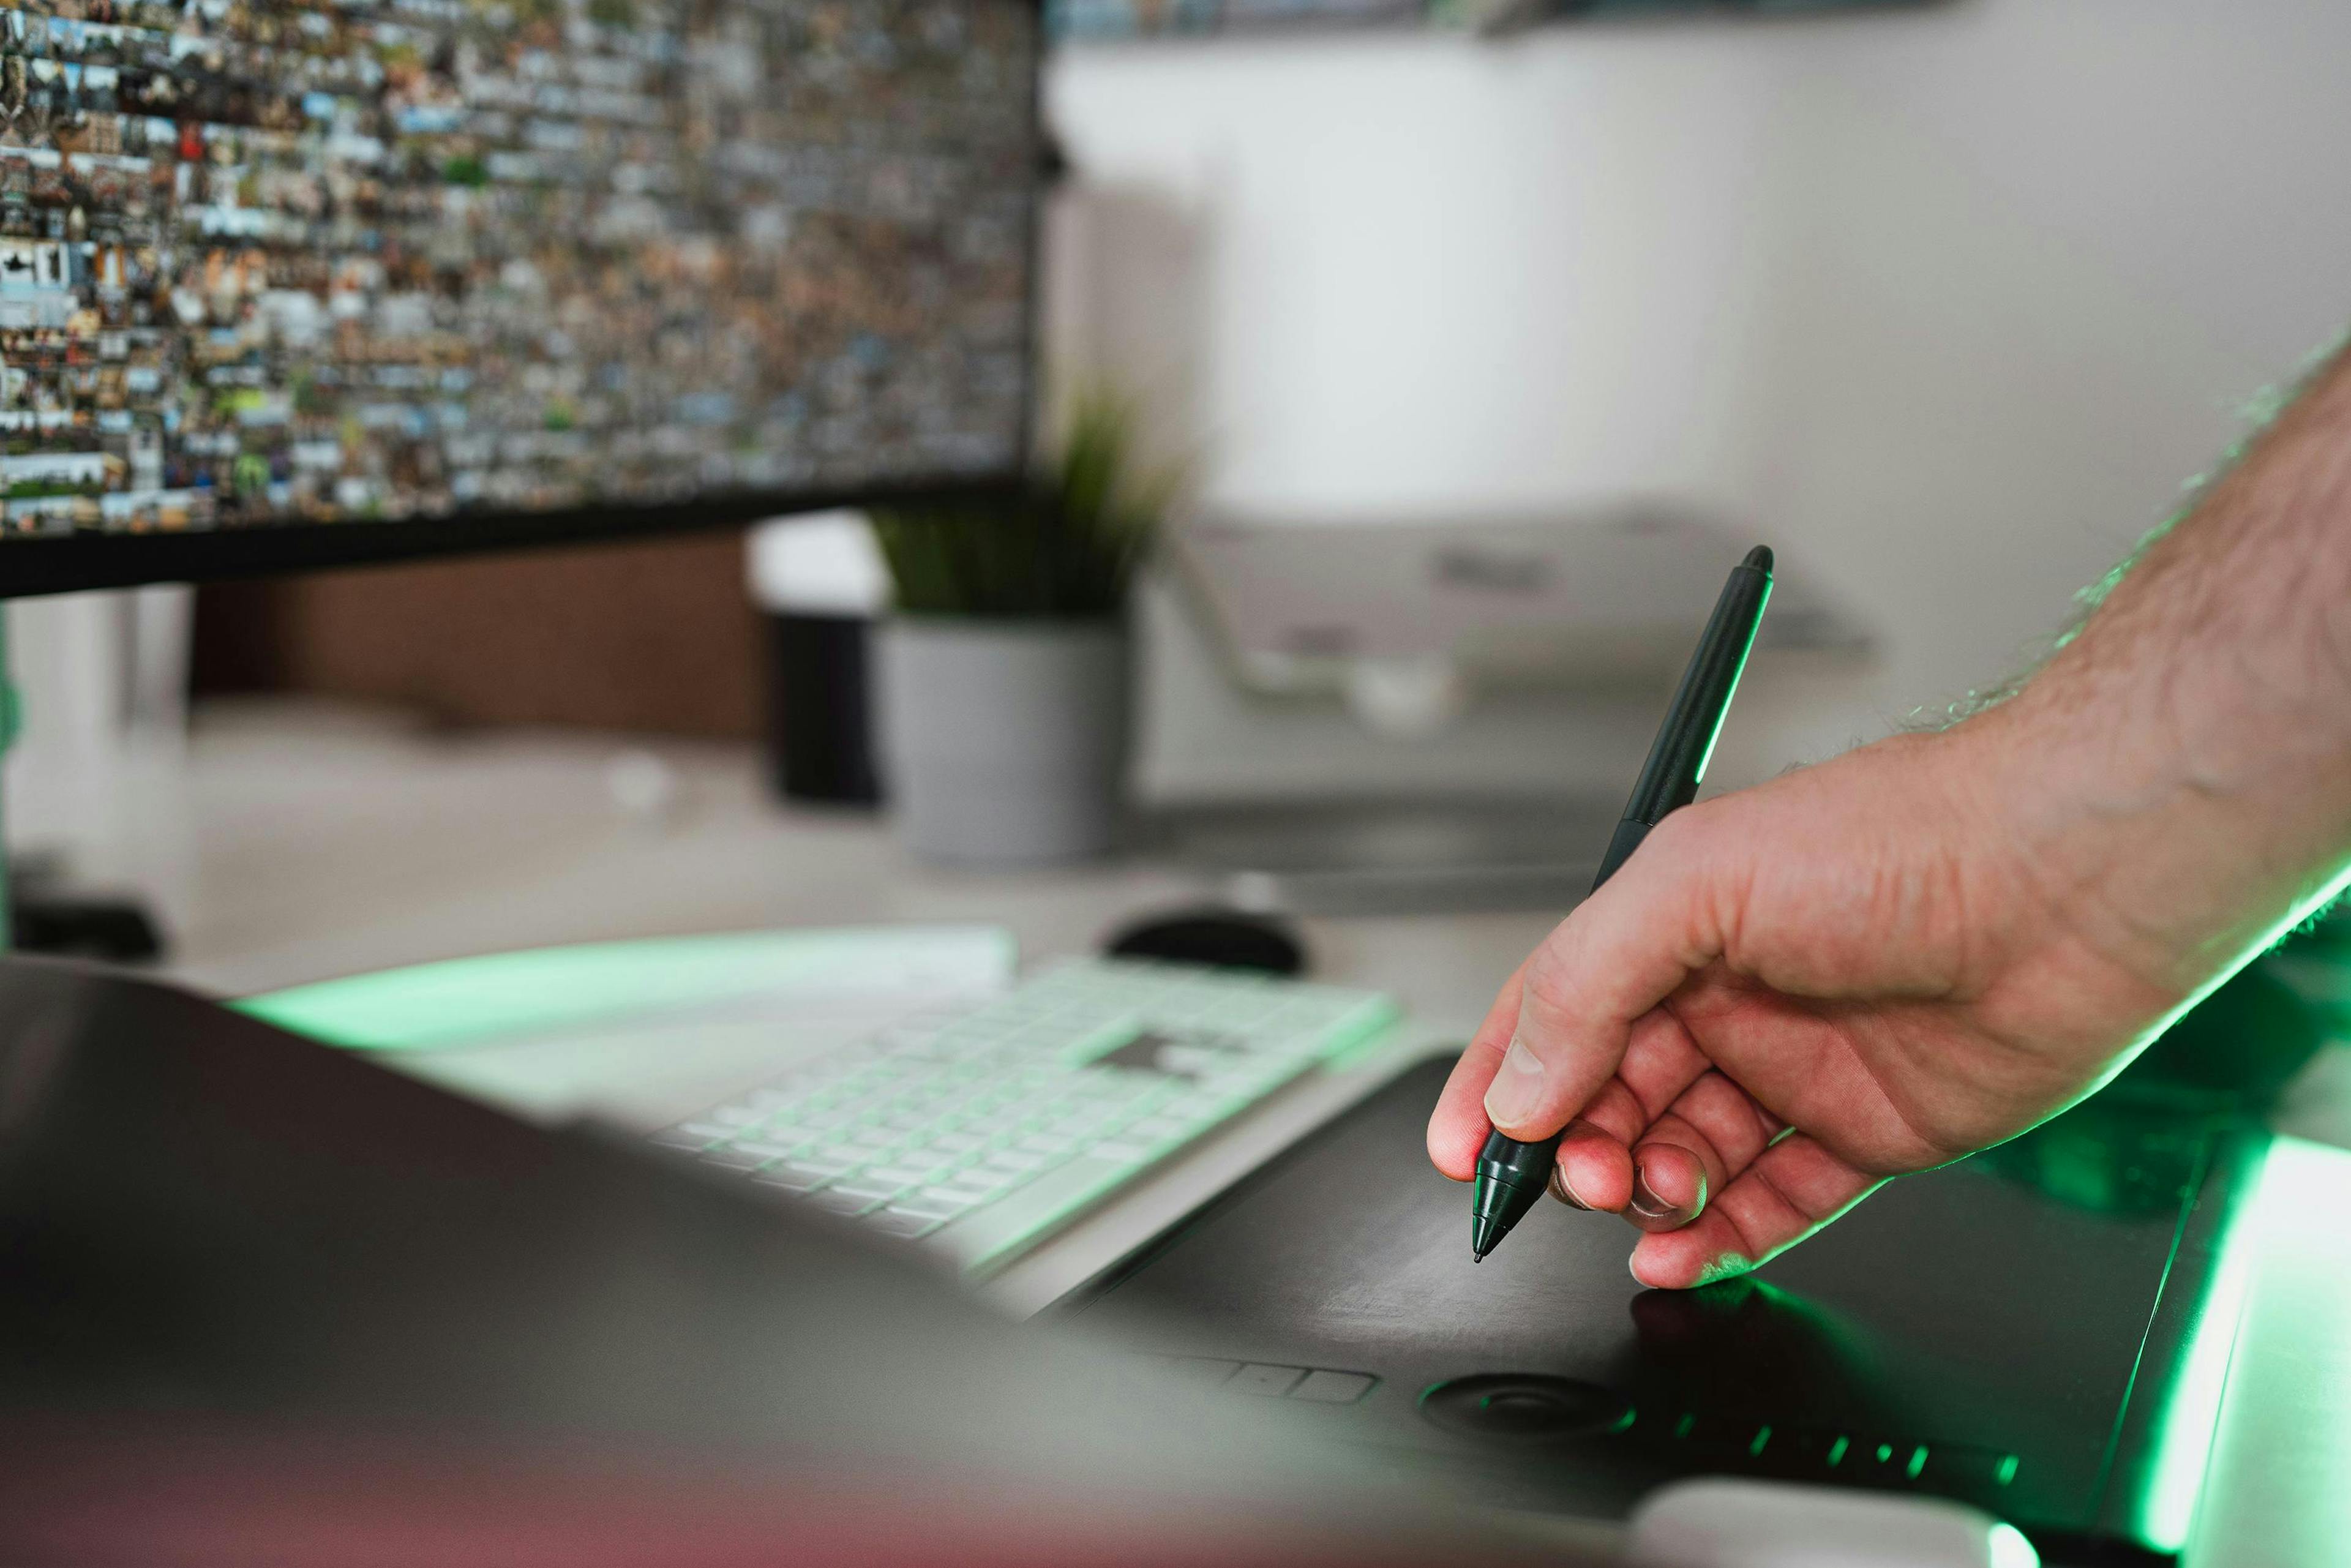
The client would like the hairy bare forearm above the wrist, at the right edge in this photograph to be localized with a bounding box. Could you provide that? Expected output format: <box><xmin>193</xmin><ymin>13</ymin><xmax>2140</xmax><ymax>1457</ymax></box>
<box><xmin>1970</xmin><ymin>343</ymin><xmax>2351</xmax><ymax>994</ymax></box>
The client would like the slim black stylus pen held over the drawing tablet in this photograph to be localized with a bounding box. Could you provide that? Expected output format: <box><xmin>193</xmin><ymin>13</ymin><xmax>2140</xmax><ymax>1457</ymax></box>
<box><xmin>1469</xmin><ymin>546</ymin><xmax>1771</xmax><ymax>1262</ymax></box>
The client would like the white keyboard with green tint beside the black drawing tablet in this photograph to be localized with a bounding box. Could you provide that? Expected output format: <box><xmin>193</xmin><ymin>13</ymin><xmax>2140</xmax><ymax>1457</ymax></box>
<box><xmin>654</xmin><ymin>959</ymin><xmax>1397</xmax><ymax>1269</ymax></box>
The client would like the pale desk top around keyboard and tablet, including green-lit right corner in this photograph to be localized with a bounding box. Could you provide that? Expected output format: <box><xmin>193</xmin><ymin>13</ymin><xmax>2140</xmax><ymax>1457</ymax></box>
<box><xmin>133</xmin><ymin>708</ymin><xmax>2351</xmax><ymax>1568</ymax></box>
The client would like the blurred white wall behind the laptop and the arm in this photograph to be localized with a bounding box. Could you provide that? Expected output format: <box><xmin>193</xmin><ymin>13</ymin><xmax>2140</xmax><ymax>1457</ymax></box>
<box><xmin>1049</xmin><ymin>0</ymin><xmax>2351</xmax><ymax>804</ymax></box>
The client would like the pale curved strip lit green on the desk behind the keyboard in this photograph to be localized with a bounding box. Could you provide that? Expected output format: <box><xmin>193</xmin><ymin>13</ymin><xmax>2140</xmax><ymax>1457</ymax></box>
<box><xmin>230</xmin><ymin>926</ymin><xmax>1013</xmax><ymax>1051</ymax></box>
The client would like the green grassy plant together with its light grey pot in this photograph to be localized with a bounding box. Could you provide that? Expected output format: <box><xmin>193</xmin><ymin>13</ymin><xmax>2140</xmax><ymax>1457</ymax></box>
<box><xmin>872</xmin><ymin>392</ymin><xmax>1173</xmax><ymax>865</ymax></box>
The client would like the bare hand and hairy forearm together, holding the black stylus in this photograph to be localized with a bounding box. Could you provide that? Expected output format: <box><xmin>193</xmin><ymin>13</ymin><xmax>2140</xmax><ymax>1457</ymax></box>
<box><xmin>1430</xmin><ymin>343</ymin><xmax>2351</xmax><ymax>1286</ymax></box>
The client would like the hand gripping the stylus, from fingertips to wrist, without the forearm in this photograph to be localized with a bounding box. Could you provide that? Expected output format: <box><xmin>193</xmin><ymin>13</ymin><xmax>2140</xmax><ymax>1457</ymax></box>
<box><xmin>1430</xmin><ymin>712</ymin><xmax>2200</xmax><ymax>1286</ymax></box>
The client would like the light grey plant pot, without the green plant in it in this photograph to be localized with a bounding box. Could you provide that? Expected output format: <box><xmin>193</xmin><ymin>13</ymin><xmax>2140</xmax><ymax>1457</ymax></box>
<box><xmin>874</xmin><ymin>616</ymin><xmax>1128</xmax><ymax>865</ymax></box>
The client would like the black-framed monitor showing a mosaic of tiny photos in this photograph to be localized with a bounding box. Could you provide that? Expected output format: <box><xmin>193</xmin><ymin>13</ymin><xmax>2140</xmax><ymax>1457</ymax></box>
<box><xmin>0</xmin><ymin>0</ymin><xmax>1037</xmax><ymax>593</ymax></box>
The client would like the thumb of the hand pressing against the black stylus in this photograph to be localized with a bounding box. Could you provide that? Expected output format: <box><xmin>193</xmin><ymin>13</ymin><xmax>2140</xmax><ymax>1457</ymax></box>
<box><xmin>1486</xmin><ymin>806</ymin><xmax>1723</xmax><ymax>1142</ymax></box>
